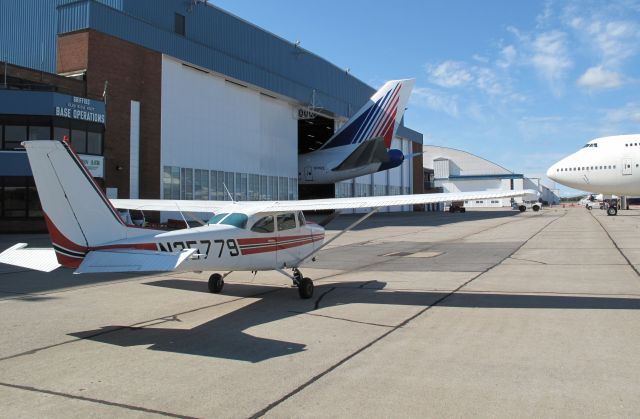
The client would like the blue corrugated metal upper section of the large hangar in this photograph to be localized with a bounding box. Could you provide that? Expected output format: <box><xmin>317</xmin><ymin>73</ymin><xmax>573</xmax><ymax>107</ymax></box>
<box><xmin>0</xmin><ymin>0</ymin><xmax>422</xmax><ymax>143</ymax></box>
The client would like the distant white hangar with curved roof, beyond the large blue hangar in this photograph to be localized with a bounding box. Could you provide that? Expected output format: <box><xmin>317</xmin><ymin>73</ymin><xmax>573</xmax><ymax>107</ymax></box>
<box><xmin>423</xmin><ymin>145</ymin><xmax>560</xmax><ymax>207</ymax></box>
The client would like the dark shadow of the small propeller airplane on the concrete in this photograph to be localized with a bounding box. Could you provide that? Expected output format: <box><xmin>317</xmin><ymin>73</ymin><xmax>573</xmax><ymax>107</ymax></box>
<box><xmin>71</xmin><ymin>280</ymin><xmax>640</xmax><ymax>363</ymax></box>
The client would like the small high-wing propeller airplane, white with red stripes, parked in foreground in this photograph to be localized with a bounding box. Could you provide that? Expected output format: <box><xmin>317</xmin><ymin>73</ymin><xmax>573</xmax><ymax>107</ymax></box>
<box><xmin>0</xmin><ymin>141</ymin><xmax>533</xmax><ymax>298</ymax></box>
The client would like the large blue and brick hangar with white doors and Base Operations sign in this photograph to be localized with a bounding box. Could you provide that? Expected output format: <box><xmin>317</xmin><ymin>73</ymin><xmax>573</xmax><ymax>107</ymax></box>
<box><xmin>0</xmin><ymin>0</ymin><xmax>422</xmax><ymax>230</ymax></box>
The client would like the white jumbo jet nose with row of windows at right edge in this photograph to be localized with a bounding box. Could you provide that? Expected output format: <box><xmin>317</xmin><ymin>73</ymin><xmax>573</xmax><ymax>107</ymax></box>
<box><xmin>547</xmin><ymin>134</ymin><xmax>640</xmax><ymax>215</ymax></box>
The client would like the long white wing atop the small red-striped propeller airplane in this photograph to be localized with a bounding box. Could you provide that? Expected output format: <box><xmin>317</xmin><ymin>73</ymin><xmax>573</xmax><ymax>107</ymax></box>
<box><xmin>111</xmin><ymin>190</ymin><xmax>537</xmax><ymax>213</ymax></box>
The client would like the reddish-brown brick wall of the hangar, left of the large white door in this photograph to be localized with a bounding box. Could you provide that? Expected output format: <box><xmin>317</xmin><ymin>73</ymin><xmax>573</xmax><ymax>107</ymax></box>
<box><xmin>57</xmin><ymin>30</ymin><xmax>162</xmax><ymax>199</ymax></box>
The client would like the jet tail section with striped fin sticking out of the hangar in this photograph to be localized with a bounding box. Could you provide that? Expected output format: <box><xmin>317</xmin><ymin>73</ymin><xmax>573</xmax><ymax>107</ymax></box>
<box><xmin>298</xmin><ymin>79</ymin><xmax>415</xmax><ymax>185</ymax></box>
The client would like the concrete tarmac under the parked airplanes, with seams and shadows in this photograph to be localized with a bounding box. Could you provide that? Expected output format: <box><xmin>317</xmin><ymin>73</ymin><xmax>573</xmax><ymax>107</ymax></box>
<box><xmin>0</xmin><ymin>208</ymin><xmax>640</xmax><ymax>418</ymax></box>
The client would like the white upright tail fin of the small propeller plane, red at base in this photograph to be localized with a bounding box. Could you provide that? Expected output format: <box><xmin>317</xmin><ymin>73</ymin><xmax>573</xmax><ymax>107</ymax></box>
<box><xmin>23</xmin><ymin>141</ymin><xmax>132</xmax><ymax>267</ymax></box>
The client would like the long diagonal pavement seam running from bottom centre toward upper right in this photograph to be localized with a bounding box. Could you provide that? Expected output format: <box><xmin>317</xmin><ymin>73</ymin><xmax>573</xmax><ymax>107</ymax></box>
<box><xmin>249</xmin><ymin>211</ymin><xmax>567</xmax><ymax>419</ymax></box>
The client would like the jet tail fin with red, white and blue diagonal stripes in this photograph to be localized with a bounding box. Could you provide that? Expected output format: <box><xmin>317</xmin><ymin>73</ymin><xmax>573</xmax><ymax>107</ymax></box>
<box><xmin>322</xmin><ymin>79</ymin><xmax>415</xmax><ymax>148</ymax></box>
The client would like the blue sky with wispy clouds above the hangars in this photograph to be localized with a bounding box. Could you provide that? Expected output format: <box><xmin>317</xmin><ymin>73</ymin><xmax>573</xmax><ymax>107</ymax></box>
<box><xmin>211</xmin><ymin>0</ymin><xmax>640</xmax><ymax>194</ymax></box>
